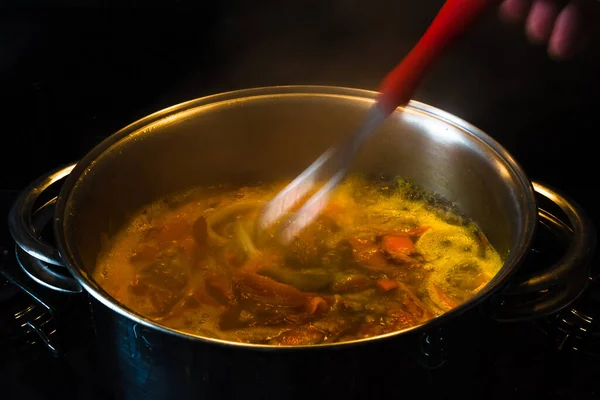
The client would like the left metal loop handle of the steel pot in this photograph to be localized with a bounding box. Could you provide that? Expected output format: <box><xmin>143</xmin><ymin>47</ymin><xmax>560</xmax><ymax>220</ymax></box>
<box><xmin>8</xmin><ymin>164</ymin><xmax>82</xmax><ymax>293</ymax></box>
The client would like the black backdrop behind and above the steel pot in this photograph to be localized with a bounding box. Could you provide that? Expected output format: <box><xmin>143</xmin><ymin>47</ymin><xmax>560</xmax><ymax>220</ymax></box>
<box><xmin>0</xmin><ymin>0</ymin><xmax>600</xmax><ymax>222</ymax></box>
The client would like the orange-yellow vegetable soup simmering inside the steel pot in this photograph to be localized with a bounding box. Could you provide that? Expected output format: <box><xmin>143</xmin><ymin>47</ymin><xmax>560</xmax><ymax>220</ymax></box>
<box><xmin>94</xmin><ymin>175</ymin><xmax>502</xmax><ymax>346</ymax></box>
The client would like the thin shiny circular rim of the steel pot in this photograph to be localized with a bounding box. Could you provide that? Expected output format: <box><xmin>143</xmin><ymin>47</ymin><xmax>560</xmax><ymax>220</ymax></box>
<box><xmin>54</xmin><ymin>85</ymin><xmax>537</xmax><ymax>351</ymax></box>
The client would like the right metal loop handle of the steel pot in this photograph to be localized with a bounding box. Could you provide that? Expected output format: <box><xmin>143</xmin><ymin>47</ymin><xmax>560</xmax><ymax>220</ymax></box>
<box><xmin>490</xmin><ymin>182</ymin><xmax>597</xmax><ymax>322</ymax></box>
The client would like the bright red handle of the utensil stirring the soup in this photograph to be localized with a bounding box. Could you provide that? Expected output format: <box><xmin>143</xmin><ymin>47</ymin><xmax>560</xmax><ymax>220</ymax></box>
<box><xmin>379</xmin><ymin>0</ymin><xmax>493</xmax><ymax>113</ymax></box>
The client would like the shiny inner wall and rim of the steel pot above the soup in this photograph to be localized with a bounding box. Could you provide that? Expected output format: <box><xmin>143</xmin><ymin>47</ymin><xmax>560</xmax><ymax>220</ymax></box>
<box><xmin>5</xmin><ymin>86</ymin><xmax>587</xmax><ymax>352</ymax></box>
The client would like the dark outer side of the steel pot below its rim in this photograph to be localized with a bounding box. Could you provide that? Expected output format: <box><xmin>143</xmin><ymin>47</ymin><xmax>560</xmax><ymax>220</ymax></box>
<box><xmin>92</xmin><ymin>300</ymin><xmax>488</xmax><ymax>400</ymax></box>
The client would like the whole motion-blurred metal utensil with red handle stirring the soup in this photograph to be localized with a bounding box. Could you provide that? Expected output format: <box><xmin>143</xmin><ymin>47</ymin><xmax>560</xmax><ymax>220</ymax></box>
<box><xmin>258</xmin><ymin>0</ymin><xmax>493</xmax><ymax>244</ymax></box>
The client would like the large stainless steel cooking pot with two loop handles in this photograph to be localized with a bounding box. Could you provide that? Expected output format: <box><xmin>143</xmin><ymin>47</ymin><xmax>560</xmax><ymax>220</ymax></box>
<box><xmin>9</xmin><ymin>86</ymin><xmax>596</xmax><ymax>399</ymax></box>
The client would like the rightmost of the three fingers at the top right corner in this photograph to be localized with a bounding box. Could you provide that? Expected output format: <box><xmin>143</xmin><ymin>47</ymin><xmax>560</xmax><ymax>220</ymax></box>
<box><xmin>548</xmin><ymin>2</ymin><xmax>583</xmax><ymax>60</ymax></box>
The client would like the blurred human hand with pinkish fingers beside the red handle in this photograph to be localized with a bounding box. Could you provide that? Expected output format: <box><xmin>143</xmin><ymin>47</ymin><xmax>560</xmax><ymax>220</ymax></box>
<box><xmin>500</xmin><ymin>0</ymin><xmax>600</xmax><ymax>59</ymax></box>
